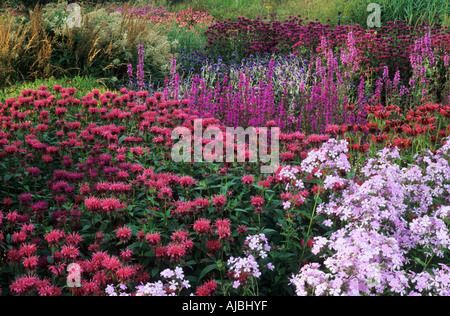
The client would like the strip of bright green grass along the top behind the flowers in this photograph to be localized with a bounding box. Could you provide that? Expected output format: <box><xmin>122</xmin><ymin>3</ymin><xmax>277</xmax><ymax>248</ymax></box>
<box><xmin>171</xmin><ymin>0</ymin><xmax>450</xmax><ymax>27</ymax></box>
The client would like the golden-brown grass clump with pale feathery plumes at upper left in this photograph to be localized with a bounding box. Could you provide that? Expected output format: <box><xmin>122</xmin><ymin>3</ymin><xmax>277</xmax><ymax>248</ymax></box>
<box><xmin>0</xmin><ymin>6</ymin><xmax>177</xmax><ymax>87</ymax></box>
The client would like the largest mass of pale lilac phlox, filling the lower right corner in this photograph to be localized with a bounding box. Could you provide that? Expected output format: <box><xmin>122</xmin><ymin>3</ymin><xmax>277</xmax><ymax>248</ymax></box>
<box><xmin>290</xmin><ymin>136</ymin><xmax>450</xmax><ymax>296</ymax></box>
